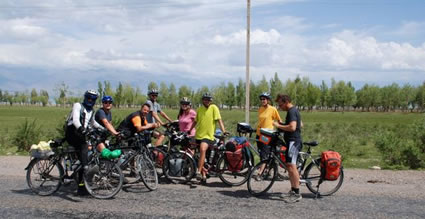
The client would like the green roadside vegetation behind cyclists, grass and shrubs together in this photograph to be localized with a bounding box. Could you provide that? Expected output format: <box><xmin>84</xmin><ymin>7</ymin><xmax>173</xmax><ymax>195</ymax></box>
<box><xmin>0</xmin><ymin>106</ymin><xmax>425</xmax><ymax>169</ymax></box>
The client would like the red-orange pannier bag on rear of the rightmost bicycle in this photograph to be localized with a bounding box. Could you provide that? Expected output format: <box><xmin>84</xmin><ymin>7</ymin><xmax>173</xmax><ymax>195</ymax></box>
<box><xmin>320</xmin><ymin>151</ymin><xmax>342</xmax><ymax>181</ymax></box>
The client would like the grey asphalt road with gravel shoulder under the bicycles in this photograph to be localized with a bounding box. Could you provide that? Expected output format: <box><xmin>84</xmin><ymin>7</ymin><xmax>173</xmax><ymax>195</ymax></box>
<box><xmin>0</xmin><ymin>156</ymin><xmax>425</xmax><ymax>218</ymax></box>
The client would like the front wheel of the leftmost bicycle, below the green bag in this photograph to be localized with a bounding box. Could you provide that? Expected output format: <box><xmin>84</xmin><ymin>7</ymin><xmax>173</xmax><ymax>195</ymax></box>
<box><xmin>84</xmin><ymin>159</ymin><xmax>124</xmax><ymax>199</ymax></box>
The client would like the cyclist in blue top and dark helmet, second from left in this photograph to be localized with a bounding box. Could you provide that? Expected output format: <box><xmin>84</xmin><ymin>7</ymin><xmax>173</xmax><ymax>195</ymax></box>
<box><xmin>94</xmin><ymin>96</ymin><xmax>121</xmax><ymax>159</ymax></box>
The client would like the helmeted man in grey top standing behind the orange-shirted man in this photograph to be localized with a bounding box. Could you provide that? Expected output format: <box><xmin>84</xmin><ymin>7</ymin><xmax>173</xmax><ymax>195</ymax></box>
<box><xmin>146</xmin><ymin>89</ymin><xmax>172</xmax><ymax>146</ymax></box>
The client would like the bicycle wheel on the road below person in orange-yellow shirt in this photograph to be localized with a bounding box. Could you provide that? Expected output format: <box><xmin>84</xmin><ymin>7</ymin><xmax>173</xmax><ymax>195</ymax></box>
<box><xmin>247</xmin><ymin>160</ymin><xmax>278</xmax><ymax>196</ymax></box>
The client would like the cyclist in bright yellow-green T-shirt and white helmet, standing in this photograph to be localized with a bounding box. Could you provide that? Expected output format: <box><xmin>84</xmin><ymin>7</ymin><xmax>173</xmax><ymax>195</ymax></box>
<box><xmin>189</xmin><ymin>93</ymin><xmax>228</xmax><ymax>183</ymax></box>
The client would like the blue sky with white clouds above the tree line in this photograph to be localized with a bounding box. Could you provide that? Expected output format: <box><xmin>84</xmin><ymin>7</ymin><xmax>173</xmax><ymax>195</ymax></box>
<box><xmin>0</xmin><ymin>0</ymin><xmax>425</xmax><ymax>96</ymax></box>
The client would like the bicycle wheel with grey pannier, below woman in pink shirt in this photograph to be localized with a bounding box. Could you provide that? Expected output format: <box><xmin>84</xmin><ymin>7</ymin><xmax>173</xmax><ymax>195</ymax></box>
<box><xmin>163</xmin><ymin>151</ymin><xmax>196</xmax><ymax>184</ymax></box>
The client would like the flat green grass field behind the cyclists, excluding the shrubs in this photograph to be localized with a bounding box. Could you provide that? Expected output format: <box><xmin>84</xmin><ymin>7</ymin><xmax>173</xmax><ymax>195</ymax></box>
<box><xmin>0</xmin><ymin>106</ymin><xmax>424</xmax><ymax>168</ymax></box>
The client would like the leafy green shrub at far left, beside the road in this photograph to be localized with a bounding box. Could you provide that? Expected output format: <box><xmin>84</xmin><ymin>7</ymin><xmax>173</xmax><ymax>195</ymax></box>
<box><xmin>13</xmin><ymin>119</ymin><xmax>41</xmax><ymax>151</ymax></box>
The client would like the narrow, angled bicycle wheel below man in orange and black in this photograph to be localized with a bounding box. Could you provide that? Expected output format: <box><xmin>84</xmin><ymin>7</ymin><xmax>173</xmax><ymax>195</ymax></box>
<box><xmin>136</xmin><ymin>154</ymin><xmax>158</xmax><ymax>191</ymax></box>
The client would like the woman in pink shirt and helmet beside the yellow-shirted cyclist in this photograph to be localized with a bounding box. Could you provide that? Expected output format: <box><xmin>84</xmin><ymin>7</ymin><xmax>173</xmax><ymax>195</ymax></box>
<box><xmin>177</xmin><ymin>97</ymin><xmax>196</xmax><ymax>136</ymax></box>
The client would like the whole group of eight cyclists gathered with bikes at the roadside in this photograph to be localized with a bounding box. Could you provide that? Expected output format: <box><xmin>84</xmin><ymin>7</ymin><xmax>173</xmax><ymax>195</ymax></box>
<box><xmin>65</xmin><ymin>89</ymin><xmax>302</xmax><ymax>202</ymax></box>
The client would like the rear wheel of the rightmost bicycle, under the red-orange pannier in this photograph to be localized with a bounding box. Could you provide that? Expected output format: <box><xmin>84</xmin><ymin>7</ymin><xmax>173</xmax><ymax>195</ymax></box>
<box><xmin>303</xmin><ymin>158</ymin><xmax>344</xmax><ymax>196</ymax></box>
